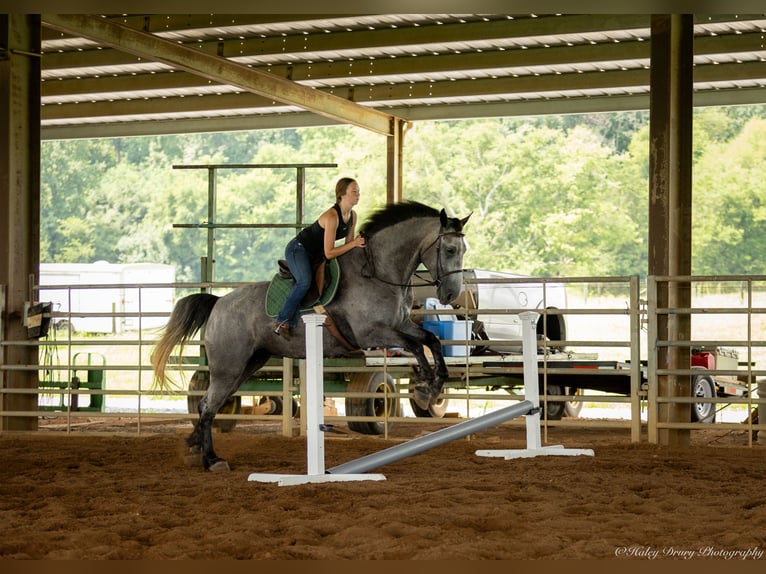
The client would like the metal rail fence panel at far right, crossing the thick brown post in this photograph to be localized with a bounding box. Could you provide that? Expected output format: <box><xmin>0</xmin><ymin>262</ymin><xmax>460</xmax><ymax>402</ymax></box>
<box><xmin>647</xmin><ymin>275</ymin><xmax>766</xmax><ymax>444</ymax></box>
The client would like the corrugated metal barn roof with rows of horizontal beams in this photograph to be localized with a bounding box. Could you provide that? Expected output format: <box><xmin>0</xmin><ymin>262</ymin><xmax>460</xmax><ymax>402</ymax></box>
<box><xmin>41</xmin><ymin>14</ymin><xmax>766</xmax><ymax>139</ymax></box>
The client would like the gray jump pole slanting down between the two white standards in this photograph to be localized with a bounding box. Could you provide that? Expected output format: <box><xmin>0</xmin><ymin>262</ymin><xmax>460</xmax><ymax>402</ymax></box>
<box><xmin>327</xmin><ymin>401</ymin><xmax>534</xmax><ymax>474</ymax></box>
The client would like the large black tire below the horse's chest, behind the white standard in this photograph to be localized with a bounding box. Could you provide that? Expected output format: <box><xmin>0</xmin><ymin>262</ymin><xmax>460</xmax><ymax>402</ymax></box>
<box><xmin>346</xmin><ymin>372</ymin><xmax>399</xmax><ymax>435</ymax></box>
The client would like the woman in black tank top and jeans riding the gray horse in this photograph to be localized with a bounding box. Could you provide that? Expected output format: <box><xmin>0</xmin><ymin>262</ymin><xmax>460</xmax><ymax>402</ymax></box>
<box><xmin>272</xmin><ymin>177</ymin><xmax>365</xmax><ymax>338</ymax></box>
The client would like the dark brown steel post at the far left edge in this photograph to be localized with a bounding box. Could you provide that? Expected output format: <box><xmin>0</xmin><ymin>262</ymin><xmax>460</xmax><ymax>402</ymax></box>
<box><xmin>0</xmin><ymin>14</ymin><xmax>40</xmax><ymax>431</ymax></box>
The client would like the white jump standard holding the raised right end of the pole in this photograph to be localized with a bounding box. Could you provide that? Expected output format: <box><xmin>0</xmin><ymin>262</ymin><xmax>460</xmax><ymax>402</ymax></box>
<box><xmin>476</xmin><ymin>311</ymin><xmax>593</xmax><ymax>460</ymax></box>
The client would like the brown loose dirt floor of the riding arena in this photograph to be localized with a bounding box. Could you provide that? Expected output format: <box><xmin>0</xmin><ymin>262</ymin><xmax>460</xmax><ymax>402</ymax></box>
<box><xmin>0</xmin><ymin>422</ymin><xmax>766</xmax><ymax>560</ymax></box>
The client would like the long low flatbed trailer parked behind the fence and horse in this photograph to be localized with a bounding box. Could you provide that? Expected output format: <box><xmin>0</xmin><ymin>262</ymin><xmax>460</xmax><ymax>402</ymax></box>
<box><xmin>188</xmin><ymin>351</ymin><xmax>631</xmax><ymax>434</ymax></box>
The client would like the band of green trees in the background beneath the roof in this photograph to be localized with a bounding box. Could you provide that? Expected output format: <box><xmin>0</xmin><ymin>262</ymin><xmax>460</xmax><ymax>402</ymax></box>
<box><xmin>40</xmin><ymin>106</ymin><xmax>766</xmax><ymax>281</ymax></box>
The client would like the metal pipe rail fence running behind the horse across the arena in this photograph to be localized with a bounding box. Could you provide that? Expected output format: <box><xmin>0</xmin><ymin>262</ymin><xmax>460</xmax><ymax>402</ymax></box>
<box><xmin>0</xmin><ymin>277</ymin><xmax>766</xmax><ymax>442</ymax></box>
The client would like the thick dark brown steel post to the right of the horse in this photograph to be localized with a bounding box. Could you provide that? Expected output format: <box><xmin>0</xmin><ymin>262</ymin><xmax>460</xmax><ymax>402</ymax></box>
<box><xmin>648</xmin><ymin>14</ymin><xmax>694</xmax><ymax>446</ymax></box>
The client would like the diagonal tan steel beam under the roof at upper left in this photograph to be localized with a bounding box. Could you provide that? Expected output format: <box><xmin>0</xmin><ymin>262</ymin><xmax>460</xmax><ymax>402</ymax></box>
<box><xmin>43</xmin><ymin>14</ymin><xmax>394</xmax><ymax>136</ymax></box>
